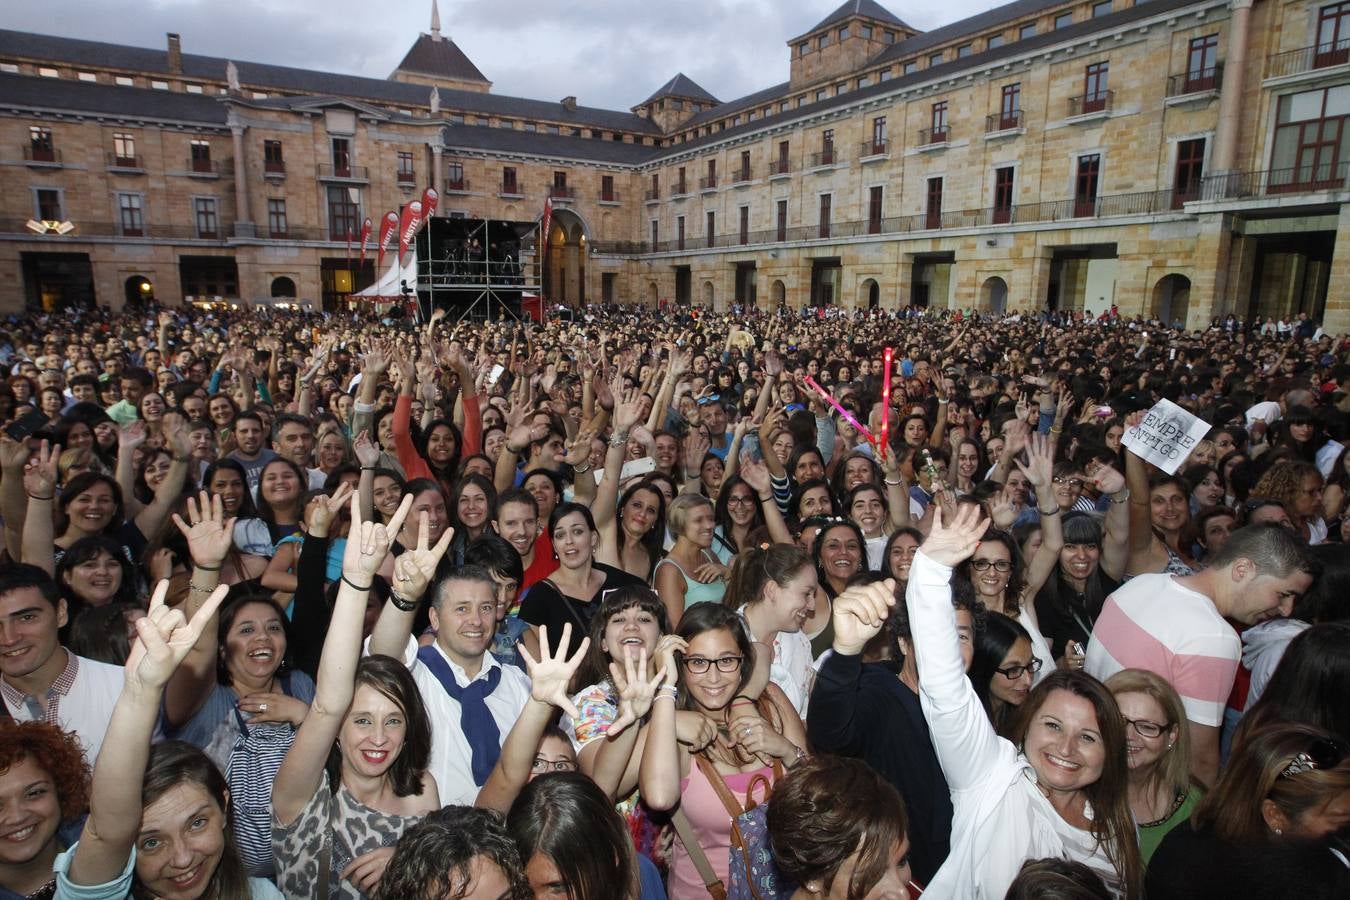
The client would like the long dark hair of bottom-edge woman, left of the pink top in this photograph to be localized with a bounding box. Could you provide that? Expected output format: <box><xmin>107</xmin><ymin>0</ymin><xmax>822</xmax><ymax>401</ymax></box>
<box><xmin>506</xmin><ymin>772</ymin><xmax>637</xmax><ymax>900</ymax></box>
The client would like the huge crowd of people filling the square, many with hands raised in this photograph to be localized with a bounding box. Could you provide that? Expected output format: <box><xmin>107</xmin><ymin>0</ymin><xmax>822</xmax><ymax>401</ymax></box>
<box><xmin>0</xmin><ymin>299</ymin><xmax>1350</xmax><ymax>900</ymax></box>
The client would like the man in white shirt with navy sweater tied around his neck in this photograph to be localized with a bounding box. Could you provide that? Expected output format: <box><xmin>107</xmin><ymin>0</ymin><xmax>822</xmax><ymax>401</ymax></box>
<box><xmin>366</xmin><ymin>565</ymin><xmax>529</xmax><ymax>806</ymax></box>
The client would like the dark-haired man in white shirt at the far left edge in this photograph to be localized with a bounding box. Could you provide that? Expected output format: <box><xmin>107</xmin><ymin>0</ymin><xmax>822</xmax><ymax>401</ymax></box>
<box><xmin>0</xmin><ymin>564</ymin><xmax>123</xmax><ymax>766</ymax></box>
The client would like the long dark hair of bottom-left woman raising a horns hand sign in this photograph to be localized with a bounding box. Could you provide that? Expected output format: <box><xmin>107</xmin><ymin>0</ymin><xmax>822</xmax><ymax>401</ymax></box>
<box><xmin>131</xmin><ymin>741</ymin><xmax>252</xmax><ymax>900</ymax></box>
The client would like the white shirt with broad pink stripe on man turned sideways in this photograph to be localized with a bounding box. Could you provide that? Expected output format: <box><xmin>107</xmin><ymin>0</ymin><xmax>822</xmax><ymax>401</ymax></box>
<box><xmin>1087</xmin><ymin>575</ymin><xmax>1242</xmax><ymax>726</ymax></box>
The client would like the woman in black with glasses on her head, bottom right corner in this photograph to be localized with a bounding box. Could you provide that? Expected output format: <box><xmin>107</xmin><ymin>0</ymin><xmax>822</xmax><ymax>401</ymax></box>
<box><xmin>1145</xmin><ymin>725</ymin><xmax>1350</xmax><ymax>900</ymax></box>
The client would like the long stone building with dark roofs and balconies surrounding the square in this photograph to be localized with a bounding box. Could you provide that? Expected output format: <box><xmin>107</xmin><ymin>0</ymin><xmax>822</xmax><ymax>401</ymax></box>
<box><xmin>0</xmin><ymin>0</ymin><xmax>1350</xmax><ymax>332</ymax></box>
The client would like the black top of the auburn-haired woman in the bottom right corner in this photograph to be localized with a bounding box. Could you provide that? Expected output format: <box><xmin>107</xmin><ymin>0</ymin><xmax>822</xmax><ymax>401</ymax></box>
<box><xmin>1145</xmin><ymin>823</ymin><xmax>1350</xmax><ymax>900</ymax></box>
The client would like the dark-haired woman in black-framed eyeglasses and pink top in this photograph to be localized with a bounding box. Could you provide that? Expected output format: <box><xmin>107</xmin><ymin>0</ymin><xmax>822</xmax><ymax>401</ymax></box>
<box><xmin>639</xmin><ymin>603</ymin><xmax>807</xmax><ymax>900</ymax></box>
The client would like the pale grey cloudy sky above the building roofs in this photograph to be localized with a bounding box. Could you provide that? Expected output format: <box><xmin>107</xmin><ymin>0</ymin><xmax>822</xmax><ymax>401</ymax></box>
<box><xmin>0</xmin><ymin>0</ymin><xmax>999</xmax><ymax>109</ymax></box>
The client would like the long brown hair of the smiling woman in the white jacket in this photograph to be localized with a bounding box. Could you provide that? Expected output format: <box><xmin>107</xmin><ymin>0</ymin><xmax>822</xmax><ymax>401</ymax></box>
<box><xmin>1015</xmin><ymin>671</ymin><xmax>1143</xmax><ymax>897</ymax></box>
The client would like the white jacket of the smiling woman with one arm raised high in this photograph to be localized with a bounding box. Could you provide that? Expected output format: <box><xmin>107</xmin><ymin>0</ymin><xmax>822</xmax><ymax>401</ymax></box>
<box><xmin>905</xmin><ymin>553</ymin><xmax>1122</xmax><ymax>900</ymax></box>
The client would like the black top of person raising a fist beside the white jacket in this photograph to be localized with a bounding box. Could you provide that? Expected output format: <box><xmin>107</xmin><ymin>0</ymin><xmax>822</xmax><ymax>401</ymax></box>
<box><xmin>806</xmin><ymin>653</ymin><xmax>952</xmax><ymax>884</ymax></box>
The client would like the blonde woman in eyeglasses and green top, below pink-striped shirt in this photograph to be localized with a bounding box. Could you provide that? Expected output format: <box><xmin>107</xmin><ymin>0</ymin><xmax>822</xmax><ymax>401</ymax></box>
<box><xmin>1106</xmin><ymin>669</ymin><xmax>1203</xmax><ymax>866</ymax></box>
